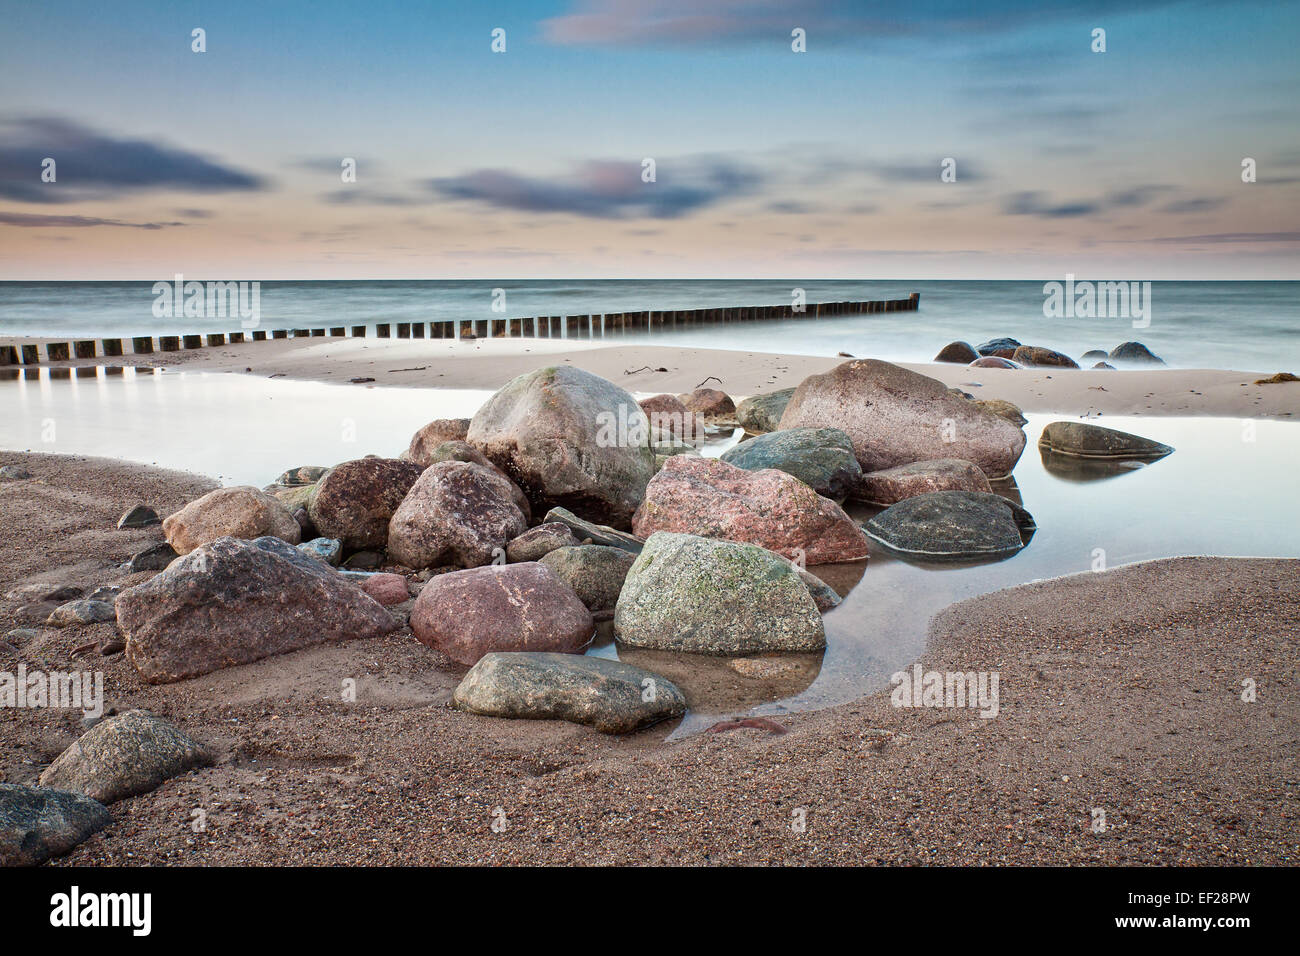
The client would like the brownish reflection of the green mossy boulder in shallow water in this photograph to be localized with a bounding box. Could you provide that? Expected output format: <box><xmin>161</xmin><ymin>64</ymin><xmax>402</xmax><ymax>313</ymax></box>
<box><xmin>619</xmin><ymin>644</ymin><xmax>822</xmax><ymax>714</ymax></box>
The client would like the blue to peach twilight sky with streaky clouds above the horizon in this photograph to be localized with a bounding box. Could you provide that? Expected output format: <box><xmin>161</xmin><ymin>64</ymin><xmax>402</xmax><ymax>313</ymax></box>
<box><xmin>0</xmin><ymin>0</ymin><xmax>1300</xmax><ymax>281</ymax></box>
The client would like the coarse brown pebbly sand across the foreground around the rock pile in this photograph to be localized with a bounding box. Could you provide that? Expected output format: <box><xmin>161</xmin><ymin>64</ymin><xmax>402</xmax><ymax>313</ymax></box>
<box><xmin>0</xmin><ymin>450</ymin><xmax>1300</xmax><ymax>865</ymax></box>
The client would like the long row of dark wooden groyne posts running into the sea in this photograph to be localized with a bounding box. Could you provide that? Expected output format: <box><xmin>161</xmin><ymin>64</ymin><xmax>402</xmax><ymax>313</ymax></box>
<box><xmin>0</xmin><ymin>293</ymin><xmax>920</xmax><ymax>365</ymax></box>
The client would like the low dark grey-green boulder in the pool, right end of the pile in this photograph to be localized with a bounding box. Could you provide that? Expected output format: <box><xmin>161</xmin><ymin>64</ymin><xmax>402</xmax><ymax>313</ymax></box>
<box><xmin>867</xmin><ymin>492</ymin><xmax>1034</xmax><ymax>561</ymax></box>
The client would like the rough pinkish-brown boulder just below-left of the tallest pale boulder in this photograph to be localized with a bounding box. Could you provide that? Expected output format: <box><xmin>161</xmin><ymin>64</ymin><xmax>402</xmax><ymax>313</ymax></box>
<box><xmin>389</xmin><ymin>462</ymin><xmax>528</xmax><ymax>568</ymax></box>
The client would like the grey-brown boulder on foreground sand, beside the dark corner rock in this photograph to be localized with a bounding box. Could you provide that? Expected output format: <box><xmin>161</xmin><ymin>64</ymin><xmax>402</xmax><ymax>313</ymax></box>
<box><xmin>40</xmin><ymin>710</ymin><xmax>212</xmax><ymax>804</ymax></box>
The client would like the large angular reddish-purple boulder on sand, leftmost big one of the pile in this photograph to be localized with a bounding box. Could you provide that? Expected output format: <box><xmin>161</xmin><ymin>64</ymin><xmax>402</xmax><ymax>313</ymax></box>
<box><xmin>117</xmin><ymin>537</ymin><xmax>398</xmax><ymax>684</ymax></box>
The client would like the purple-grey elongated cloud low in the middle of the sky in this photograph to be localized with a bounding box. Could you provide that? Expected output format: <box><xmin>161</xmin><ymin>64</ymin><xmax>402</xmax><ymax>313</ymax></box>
<box><xmin>429</xmin><ymin>157</ymin><xmax>763</xmax><ymax>219</ymax></box>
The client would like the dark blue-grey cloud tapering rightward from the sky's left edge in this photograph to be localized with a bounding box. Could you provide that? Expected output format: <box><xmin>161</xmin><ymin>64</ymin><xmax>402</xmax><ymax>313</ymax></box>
<box><xmin>0</xmin><ymin>117</ymin><xmax>265</xmax><ymax>203</ymax></box>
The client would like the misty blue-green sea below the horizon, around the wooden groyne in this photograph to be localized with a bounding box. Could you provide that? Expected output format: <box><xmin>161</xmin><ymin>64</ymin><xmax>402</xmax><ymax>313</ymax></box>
<box><xmin>0</xmin><ymin>276</ymin><xmax>1300</xmax><ymax>372</ymax></box>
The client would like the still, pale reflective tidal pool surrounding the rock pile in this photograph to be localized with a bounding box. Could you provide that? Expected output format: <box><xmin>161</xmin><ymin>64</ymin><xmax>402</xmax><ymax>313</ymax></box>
<box><xmin>0</xmin><ymin>368</ymin><xmax>1300</xmax><ymax>736</ymax></box>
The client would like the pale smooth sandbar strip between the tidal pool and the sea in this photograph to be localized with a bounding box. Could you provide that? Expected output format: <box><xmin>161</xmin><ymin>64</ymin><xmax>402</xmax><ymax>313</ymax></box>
<box><xmin>5</xmin><ymin>338</ymin><xmax>1300</xmax><ymax>419</ymax></box>
